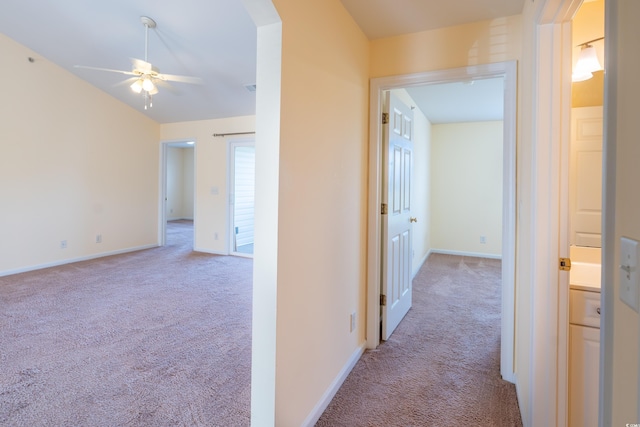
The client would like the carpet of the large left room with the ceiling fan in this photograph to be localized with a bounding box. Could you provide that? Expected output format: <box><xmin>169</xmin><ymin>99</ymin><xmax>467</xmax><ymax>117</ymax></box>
<box><xmin>0</xmin><ymin>221</ymin><xmax>252</xmax><ymax>427</ymax></box>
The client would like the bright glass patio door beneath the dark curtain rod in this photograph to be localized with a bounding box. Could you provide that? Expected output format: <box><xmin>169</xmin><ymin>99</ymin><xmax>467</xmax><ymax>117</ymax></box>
<box><xmin>229</xmin><ymin>140</ymin><xmax>256</xmax><ymax>257</ymax></box>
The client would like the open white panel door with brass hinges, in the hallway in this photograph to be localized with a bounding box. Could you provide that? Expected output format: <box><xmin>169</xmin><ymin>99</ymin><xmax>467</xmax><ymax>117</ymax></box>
<box><xmin>381</xmin><ymin>92</ymin><xmax>413</xmax><ymax>340</ymax></box>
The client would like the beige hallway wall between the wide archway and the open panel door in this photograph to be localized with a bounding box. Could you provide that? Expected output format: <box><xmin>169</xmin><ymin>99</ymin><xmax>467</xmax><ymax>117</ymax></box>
<box><xmin>270</xmin><ymin>0</ymin><xmax>369</xmax><ymax>427</ymax></box>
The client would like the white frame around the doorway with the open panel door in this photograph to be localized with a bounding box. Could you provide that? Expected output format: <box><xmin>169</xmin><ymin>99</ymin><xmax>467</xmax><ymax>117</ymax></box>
<box><xmin>366</xmin><ymin>61</ymin><xmax>517</xmax><ymax>382</ymax></box>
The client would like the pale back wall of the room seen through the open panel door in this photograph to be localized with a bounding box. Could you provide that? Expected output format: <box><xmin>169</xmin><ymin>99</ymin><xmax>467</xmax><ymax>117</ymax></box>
<box><xmin>431</xmin><ymin>121</ymin><xmax>503</xmax><ymax>258</ymax></box>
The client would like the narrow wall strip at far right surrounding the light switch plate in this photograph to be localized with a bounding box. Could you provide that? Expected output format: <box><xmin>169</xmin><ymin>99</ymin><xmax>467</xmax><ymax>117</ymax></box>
<box><xmin>604</xmin><ymin>0</ymin><xmax>640</xmax><ymax>425</ymax></box>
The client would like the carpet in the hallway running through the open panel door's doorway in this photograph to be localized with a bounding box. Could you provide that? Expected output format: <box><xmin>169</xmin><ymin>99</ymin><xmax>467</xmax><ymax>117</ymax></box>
<box><xmin>316</xmin><ymin>254</ymin><xmax>522</xmax><ymax>427</ymax></box>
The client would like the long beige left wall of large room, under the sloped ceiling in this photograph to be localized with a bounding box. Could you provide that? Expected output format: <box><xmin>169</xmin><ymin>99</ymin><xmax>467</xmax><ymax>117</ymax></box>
<box><xmin>0</xmin><ymin>35</ymin><xmax>160</xmax><ymax>274</ymax></box>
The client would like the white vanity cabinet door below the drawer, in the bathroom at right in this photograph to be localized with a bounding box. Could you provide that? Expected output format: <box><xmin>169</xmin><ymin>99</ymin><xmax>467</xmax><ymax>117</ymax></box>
<box><xmin>569</xmin><ymin>325</ymin><xmax>600</xmax><ymax>427</ymax></box>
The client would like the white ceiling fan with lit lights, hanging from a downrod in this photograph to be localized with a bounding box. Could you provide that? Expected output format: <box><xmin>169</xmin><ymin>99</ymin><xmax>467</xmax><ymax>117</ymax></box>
<box><xmin>75</xmin><ymin>16</ymin><xmax>202</xmax><ymax>110</ymax></box>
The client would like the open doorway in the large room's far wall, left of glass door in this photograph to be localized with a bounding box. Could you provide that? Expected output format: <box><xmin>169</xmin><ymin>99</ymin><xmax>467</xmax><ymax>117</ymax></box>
<box><xmin>159</xmin><ymin>140</ymin><xmax>196</xmax><ymax>246</ymax></box>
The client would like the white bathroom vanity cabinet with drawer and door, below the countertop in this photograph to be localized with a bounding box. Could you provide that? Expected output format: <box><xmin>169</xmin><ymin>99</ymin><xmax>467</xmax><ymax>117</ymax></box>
<box><xmin>569</xmin><ymin>289</ymin><xmax>600</xmax><ymax>427</ymax></box>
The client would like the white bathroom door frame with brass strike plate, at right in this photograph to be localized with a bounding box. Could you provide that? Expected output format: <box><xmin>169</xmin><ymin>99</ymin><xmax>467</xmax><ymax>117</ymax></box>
<box><xmin>526</xmin><ymin>0</ymin><xmax>588</xmax><ymax>426</ymax></box>
